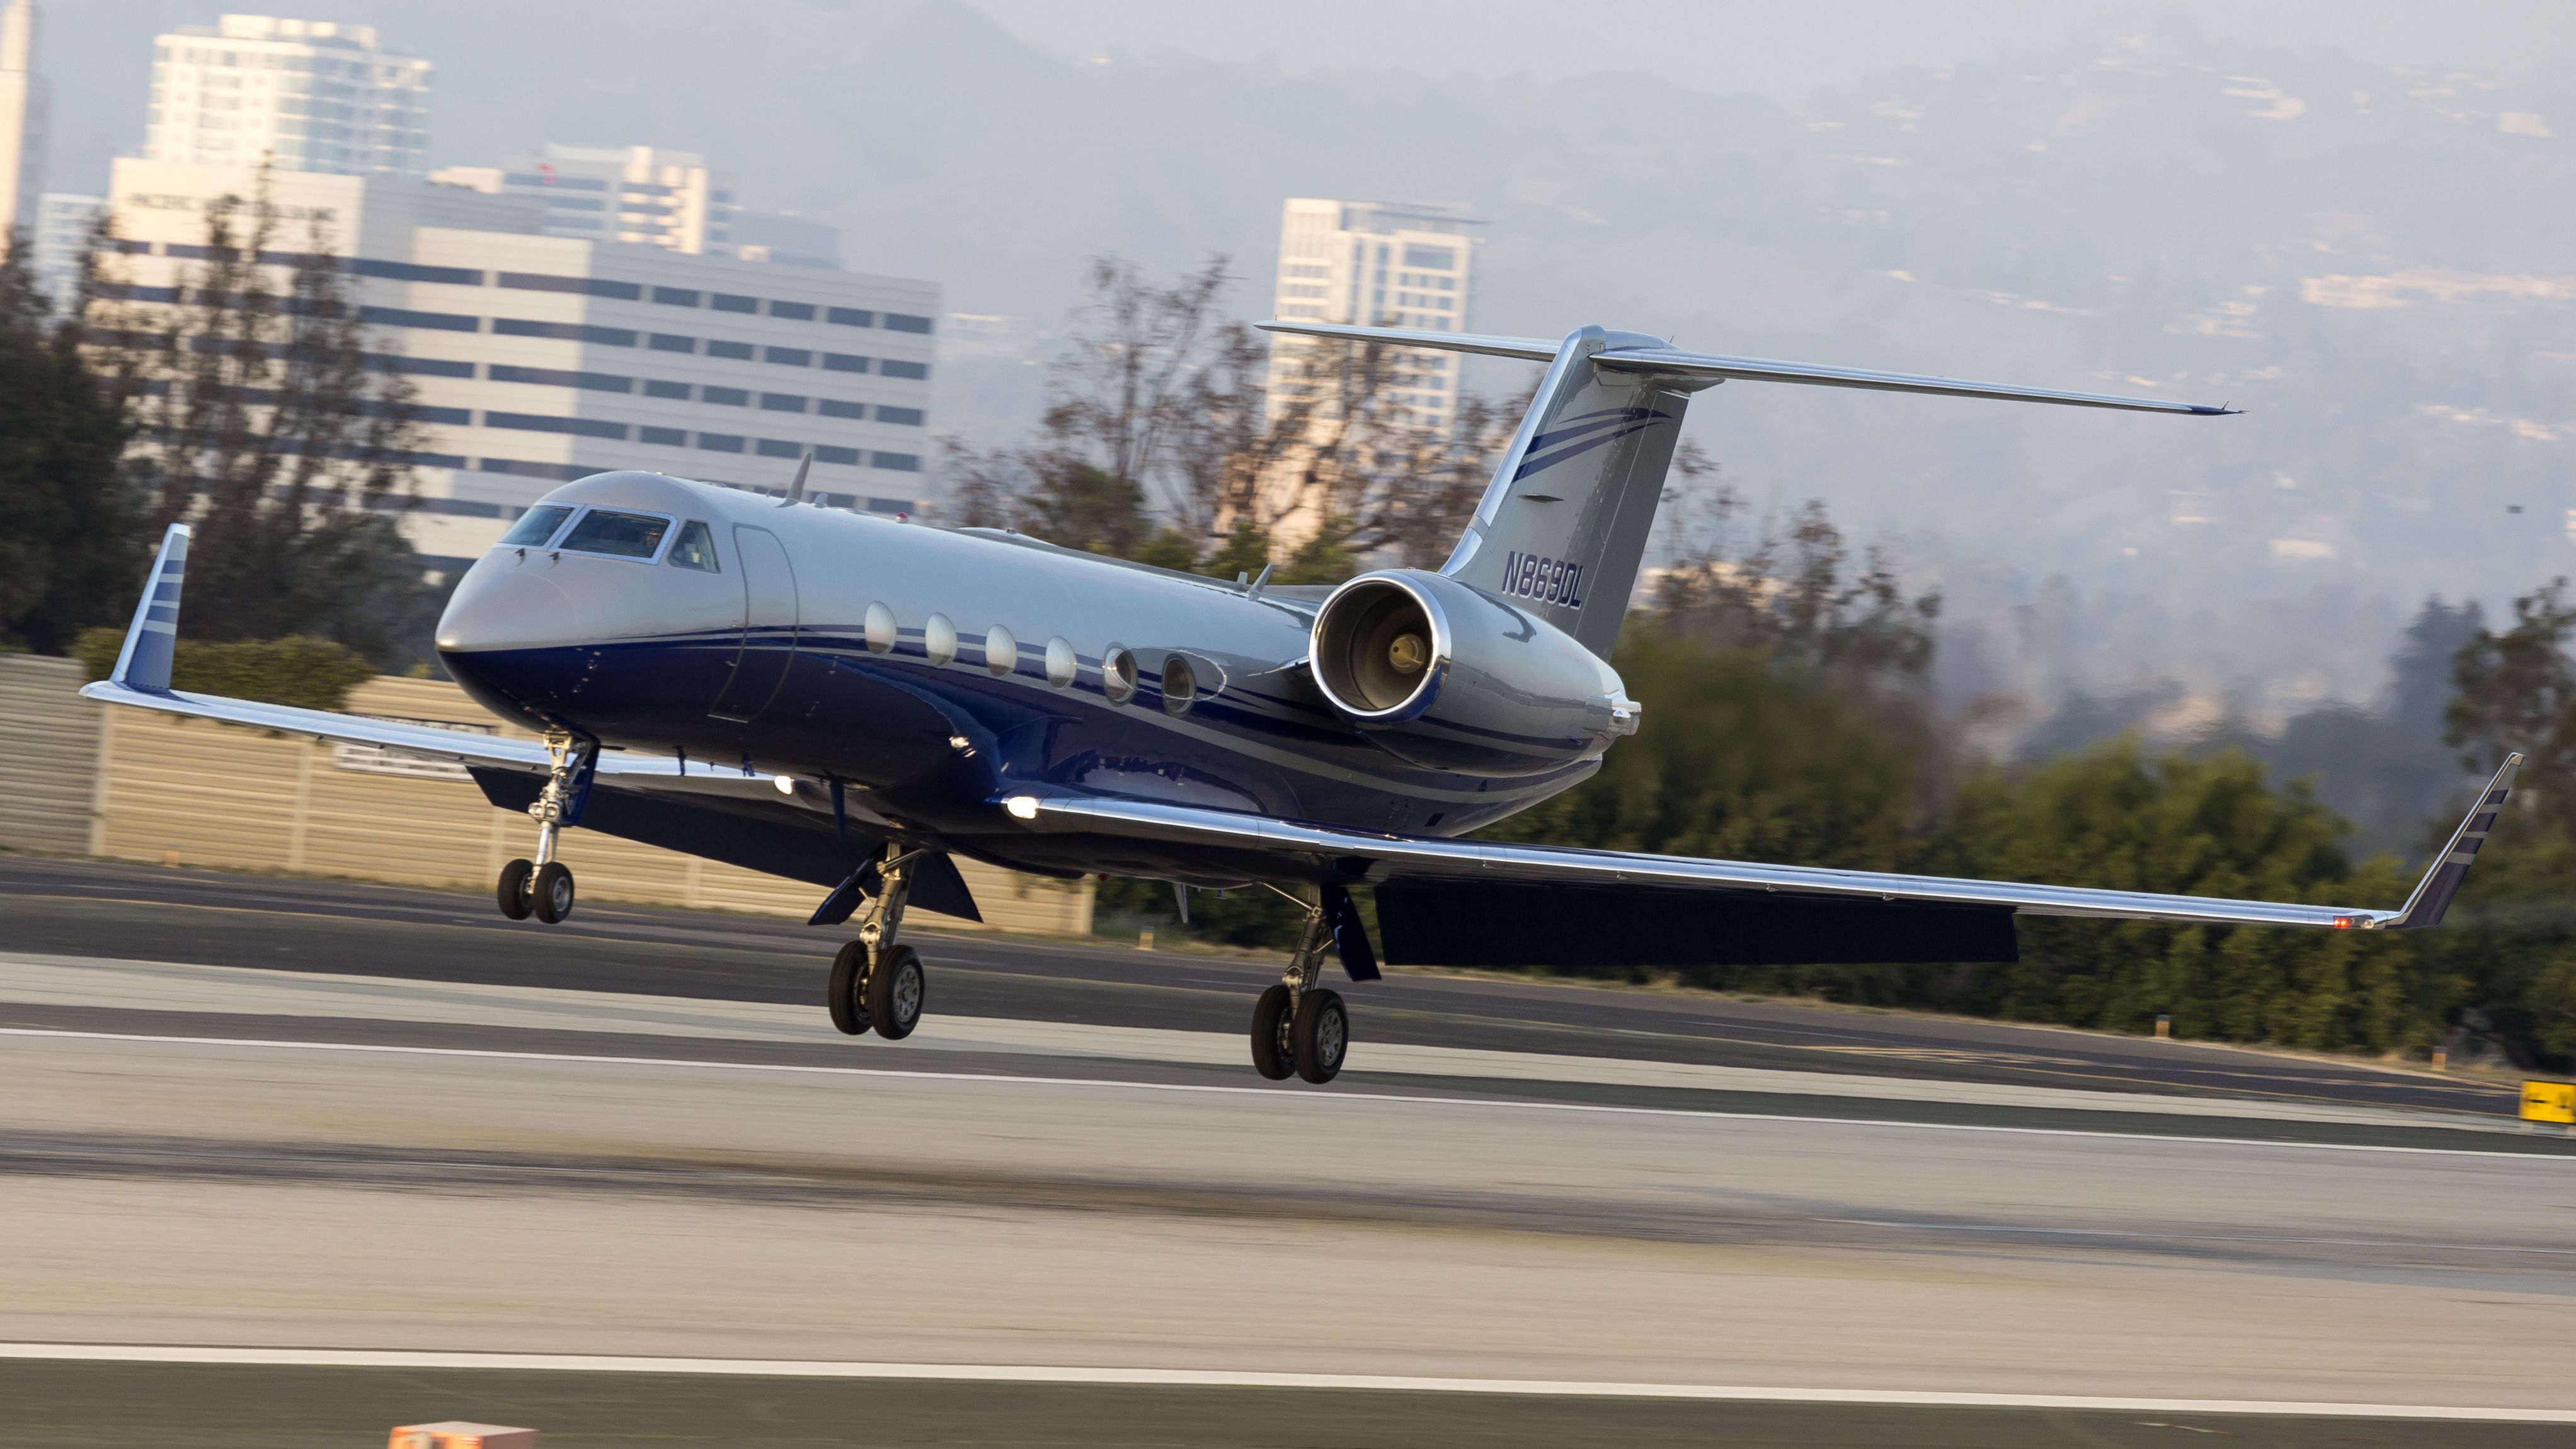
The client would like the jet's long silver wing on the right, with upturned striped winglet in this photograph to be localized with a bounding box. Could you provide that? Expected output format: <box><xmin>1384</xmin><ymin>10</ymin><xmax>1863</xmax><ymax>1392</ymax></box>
<box><xmin>1005</xmin><ymin>755</ymin><xmax>2522</xmax><ymax>931</ymax></box>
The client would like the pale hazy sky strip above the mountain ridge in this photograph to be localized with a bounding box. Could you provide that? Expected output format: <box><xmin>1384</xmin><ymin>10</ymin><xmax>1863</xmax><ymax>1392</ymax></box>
<box><xmin>971</xmin><ymin>0</ymin><xmax>2576</xmax><ymax>98</ymax></box>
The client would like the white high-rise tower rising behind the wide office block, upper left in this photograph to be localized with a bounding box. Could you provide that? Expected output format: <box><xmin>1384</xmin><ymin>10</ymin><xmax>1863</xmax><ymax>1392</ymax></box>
<box><xmin>144</xmin><ymin>16</ymin><xmax>430</xmax><ymax>178</ymax></box>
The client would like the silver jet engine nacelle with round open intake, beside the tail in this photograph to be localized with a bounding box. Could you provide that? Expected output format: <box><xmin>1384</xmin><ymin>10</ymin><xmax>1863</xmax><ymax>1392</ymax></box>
<box><xmin>1308</xmin><ymin>570</ymin><xmax>1639</xmax><ymax>776</ymax></box>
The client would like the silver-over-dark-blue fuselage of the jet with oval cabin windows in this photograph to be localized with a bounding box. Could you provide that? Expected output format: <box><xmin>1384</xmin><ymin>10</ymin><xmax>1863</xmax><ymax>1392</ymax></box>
<box><xmin>438</xmin><ymin>472</ymin><xmax>1600</xmax><ymax>885</ymax></box>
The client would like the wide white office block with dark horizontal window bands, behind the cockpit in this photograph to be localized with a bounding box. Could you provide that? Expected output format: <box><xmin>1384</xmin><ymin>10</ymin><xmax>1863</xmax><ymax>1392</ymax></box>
<box><xmin>111</xmin><ymin>160</ymin><xmax>937</xmax><ymax>567</ymax></box>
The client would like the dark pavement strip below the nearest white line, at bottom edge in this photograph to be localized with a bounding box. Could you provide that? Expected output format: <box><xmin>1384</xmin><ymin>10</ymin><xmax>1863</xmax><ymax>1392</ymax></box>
<box><xmin>0</xmin><ymin>1359</ymin><xmax>2571</xmax><ymax>1449</ymax></box>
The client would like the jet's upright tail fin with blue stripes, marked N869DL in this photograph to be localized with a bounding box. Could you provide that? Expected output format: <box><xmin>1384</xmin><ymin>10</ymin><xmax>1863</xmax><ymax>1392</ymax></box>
<box><xmin>1440</xmin><ymin>328</ymin><xmax>1713</xmax><ymax>658</ymax></box>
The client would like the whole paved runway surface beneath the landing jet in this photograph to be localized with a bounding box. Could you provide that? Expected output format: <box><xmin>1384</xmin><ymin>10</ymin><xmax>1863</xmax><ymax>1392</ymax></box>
<box><xmin>0</xmin><ymin>861</ymin><xmax>2576</xmax><ymax>1444</ymax></box>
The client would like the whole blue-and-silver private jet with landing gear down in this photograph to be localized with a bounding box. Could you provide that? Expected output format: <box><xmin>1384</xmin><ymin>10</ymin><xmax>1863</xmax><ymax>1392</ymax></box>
<box><xmin>85</xmin><ymin>323</ymin><xmax>2519</xmax><ymax>1083</ymax></box>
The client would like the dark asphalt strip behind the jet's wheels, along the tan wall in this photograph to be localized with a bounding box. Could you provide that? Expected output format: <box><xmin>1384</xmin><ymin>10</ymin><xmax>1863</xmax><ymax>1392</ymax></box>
<box><xmin>0</xmin><ymin>856</ymin><xmax>2517</xmax><ymax>1116</ymax></box>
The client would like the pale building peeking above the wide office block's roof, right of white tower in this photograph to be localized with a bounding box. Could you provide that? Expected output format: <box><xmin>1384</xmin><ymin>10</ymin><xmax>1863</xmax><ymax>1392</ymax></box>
<box><xmin>430</xmin><ymin>142</ymin><xmax>736</xmax><ymax>255</ymax></box>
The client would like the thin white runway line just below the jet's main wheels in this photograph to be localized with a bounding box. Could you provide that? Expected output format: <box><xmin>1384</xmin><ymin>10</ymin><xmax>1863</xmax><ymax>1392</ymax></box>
<box><xmin>0</xmin><ymin>1026</ymin><xmax>2576</xmax><ymax>1163</ymax></box>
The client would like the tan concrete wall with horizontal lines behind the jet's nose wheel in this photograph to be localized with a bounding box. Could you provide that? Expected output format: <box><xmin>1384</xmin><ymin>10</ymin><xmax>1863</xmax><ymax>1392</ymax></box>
<box><xmin>0</xmin><ymin>655</ymin><xmax>1092</xmax><ymax>936</ymax></box>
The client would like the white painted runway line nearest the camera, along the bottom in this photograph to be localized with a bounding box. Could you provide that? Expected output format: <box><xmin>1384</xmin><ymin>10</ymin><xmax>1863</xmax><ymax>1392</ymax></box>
<box><xmin>0</xmin><ymin>1343</ymin><xmax>2576</xmax><ymax>1423</ymax></box>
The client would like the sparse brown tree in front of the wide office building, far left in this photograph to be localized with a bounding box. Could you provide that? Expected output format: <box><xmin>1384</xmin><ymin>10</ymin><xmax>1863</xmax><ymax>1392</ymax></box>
<box><xmin>85</xmin><ymin>178</ymin><xmax>425</xmax><ymax>663</ymax></box>
